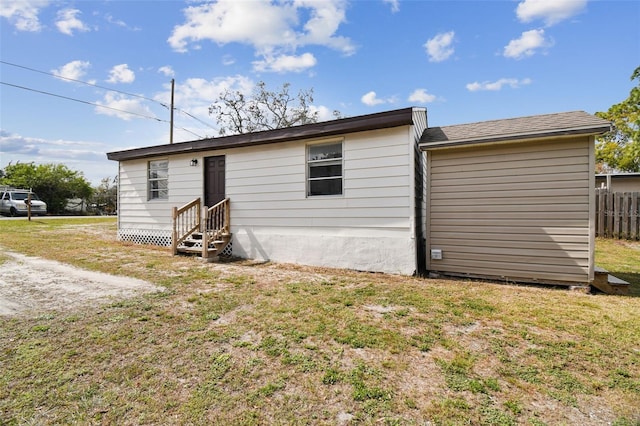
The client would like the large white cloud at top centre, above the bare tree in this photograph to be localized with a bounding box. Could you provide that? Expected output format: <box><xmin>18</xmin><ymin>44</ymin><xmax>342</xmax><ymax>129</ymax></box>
<box><xmin>167</xmin><ymin>0</ymin><xmax>355</xmax><ymax>70</ymax></box>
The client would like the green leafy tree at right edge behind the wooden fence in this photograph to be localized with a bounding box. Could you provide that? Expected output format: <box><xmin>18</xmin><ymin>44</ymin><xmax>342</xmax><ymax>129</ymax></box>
<box><xmin>596</xmin><ymin>67</ymin><xmax>640</xmax><ymax>172</ymax></box>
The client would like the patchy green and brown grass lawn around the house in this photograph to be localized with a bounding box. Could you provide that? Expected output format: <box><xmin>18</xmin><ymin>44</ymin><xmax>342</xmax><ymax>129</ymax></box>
<box><xmin>0</xmin><ymin>218</ymin><xmax>640</xmax><ymax>425</ymax></box>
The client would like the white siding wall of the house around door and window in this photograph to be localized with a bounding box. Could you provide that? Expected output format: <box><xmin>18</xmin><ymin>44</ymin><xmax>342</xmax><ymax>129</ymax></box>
<box><xmin>119</xmin><ymin>126</ymin><xmax>416</xmax><ymax>274</ymax></box>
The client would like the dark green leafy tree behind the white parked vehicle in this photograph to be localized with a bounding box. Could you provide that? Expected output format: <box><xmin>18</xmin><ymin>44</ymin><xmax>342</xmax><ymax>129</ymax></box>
<box><xmin>0</xmin><ymin>163</ymin><xmax>93</xmax><ymax>214</ymax></box>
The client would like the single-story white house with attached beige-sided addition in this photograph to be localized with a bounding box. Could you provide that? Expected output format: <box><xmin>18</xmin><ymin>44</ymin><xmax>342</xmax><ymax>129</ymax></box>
<box><xmin>107</xmin><ymin>108</ymin><xmax>610</xmax><ymax>284</ymax></box>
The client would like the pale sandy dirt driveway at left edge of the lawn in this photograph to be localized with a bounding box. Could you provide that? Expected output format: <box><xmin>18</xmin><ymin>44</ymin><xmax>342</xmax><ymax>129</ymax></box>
<box><xmin>0</xmin><ymin>251</ymin><xmax>164</xmax><ymax>316</ymax></box>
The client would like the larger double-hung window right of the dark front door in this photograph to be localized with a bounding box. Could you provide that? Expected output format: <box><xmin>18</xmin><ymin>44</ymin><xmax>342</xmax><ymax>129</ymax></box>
<box><xmin>307</xmin><ymin>142</ymin><xmax>342</xmax><ymax>196</ymax></box>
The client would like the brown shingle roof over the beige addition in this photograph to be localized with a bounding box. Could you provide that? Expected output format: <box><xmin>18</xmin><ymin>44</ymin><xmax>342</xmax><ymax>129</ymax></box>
<box><xmin>420</xmin><ymin>111</ymin><xmax>611</xmax><ymax>149</ymax></box>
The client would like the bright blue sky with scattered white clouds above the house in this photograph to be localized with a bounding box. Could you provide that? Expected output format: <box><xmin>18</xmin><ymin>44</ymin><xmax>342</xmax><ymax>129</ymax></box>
<box><xmin>0</xmin><ymin>0</ymin><xmax>640</xmax><ymax>184</ymax></box>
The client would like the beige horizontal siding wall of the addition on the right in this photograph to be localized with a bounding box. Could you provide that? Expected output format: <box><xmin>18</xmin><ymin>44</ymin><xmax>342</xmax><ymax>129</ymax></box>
<box><xmin>427</xmin><ymin>137</ymin><xmax>592</xmax><ymax>283</ymax></box>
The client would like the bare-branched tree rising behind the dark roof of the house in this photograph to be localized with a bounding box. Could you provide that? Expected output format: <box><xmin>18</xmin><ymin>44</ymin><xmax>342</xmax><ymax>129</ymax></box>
<box><xmin>209</xmin><ymin>81</ymin><xmax>340</xmax><ymax>136</ymax></box>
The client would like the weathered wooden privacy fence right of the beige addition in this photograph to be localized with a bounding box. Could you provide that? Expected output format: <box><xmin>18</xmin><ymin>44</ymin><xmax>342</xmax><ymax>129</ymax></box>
<box><xmin>596</xmin><ymin>189</ymin><xmax>640</xmax><ymax>240</ymax></box>
